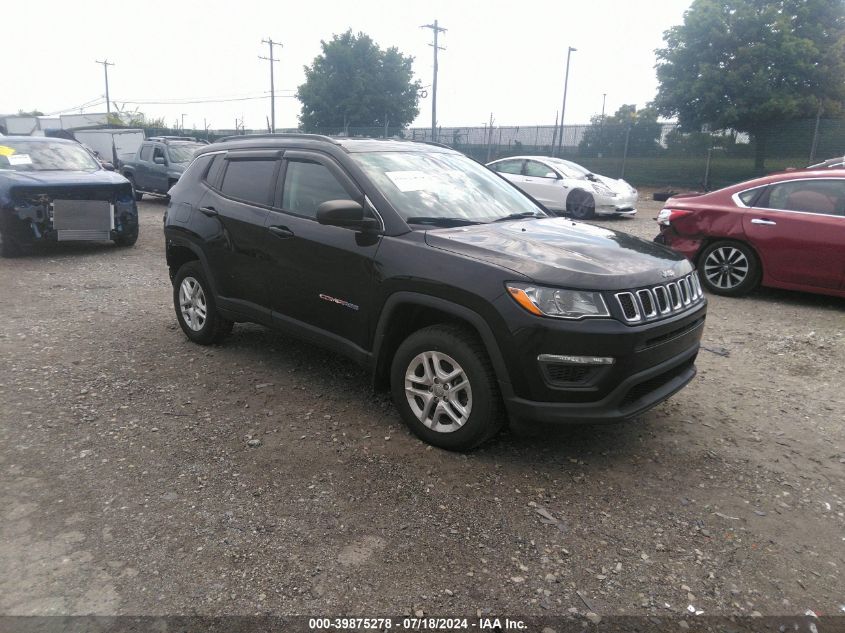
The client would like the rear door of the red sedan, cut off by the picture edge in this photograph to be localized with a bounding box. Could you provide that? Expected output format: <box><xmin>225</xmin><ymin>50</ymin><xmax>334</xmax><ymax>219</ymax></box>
<box><xmin>742</xmin><ymin>178</ymin><xmax>845</xmax><ymax>288</ymax></box>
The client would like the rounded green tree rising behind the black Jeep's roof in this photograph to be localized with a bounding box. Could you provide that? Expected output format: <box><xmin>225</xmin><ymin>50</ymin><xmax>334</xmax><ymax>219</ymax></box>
<box><xmin>296</xmin><ymin>30</ymin><xmax>421</xmax><ymax>132</ymax></box>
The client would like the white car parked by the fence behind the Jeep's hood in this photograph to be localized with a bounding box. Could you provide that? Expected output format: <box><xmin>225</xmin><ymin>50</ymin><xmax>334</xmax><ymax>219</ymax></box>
<box><xmin>487</xmin><ymin>156</ymin><xmax>639</xmax><ymax>220</ymax></box>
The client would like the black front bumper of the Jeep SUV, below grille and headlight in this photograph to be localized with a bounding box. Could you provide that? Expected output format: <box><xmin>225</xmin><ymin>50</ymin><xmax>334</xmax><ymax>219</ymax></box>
<box><xmin>497</xmin><ymin>297</ymin><xmax>707</xmax><ymax>423</ymax></box>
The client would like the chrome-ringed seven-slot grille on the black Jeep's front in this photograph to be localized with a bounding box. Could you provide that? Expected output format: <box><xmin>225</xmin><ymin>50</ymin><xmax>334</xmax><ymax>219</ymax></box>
<box><xmin>616</xmin><ymin>272</ymin><xmax>704</xmax><ymax>323</ymax></box>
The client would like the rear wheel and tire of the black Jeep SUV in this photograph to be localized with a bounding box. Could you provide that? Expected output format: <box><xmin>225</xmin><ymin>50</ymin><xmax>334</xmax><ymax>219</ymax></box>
<box><xmin>173</xmin><ymin>261</ymin><xmax>234</xmax><ymax>345</ymax></box>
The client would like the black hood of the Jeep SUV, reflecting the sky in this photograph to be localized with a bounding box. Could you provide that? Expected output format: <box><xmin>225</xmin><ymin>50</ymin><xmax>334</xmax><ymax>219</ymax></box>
<box><xmin>426</xmin><ymin>218</ymin><xmax>692</xmax><ymax>290</ymax></box>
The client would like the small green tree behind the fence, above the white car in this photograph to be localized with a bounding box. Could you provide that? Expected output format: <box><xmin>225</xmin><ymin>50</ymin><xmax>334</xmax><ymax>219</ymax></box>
<box><xmin>578</xmin><ymin>104</ymin><xmax>663</xmax><ymax>156</ymax></box>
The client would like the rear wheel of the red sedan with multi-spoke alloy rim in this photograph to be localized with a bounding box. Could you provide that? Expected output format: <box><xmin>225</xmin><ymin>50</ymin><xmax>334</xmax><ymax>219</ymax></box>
<box><xmin>698</xmin><ymin>240</ymin><xmax>762</xmax><ymax>297</ymax></box>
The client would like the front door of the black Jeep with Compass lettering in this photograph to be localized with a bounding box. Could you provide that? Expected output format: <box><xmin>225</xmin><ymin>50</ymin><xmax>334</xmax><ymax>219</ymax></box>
<box><xmin>266</xmin><ymin>150</ymin><xmax>381</xmax><ymax>349</ymax></box>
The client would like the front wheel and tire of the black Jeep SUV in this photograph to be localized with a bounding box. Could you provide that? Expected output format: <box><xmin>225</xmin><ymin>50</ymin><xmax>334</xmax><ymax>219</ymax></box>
<box><xmin>390</xmin><ymin>325</ymin><xmax>505</xmax><ymax>451</ymax></box>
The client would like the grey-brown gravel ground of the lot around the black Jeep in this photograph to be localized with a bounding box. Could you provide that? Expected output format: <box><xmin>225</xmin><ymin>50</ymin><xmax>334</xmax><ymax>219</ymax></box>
<box><xmin>0</xmin><ymin>194</ymin><xmax>845</xmax><ymax>615</ymax></box>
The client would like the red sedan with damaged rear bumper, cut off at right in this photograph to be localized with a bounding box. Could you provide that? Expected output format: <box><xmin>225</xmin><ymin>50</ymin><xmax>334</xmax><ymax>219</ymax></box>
<box><xmin>655</xmin><ymin>169</ymin><xmax>845</xmax><ymax>297</ymax></box>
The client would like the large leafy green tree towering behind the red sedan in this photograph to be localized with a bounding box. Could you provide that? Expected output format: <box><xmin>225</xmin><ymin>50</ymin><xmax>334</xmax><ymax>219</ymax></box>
<box><xmin>654</xmin><ymin>0</ymin><xmax>845</xmax><ymax>170</ymax></box>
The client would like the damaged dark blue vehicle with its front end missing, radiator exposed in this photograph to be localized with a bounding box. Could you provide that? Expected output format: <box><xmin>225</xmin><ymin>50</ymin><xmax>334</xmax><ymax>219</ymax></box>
<box><xmin>0</xmin><ymin>136</ymin><xmax>138</xmax><ymax>257</ymax></box>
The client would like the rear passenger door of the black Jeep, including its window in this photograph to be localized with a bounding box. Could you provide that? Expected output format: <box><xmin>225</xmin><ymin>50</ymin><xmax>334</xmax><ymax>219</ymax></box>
<box><xmin>198</xmin><ymin>150</ymin><xmax>281</xmax><ymax>321</ymax></box>
